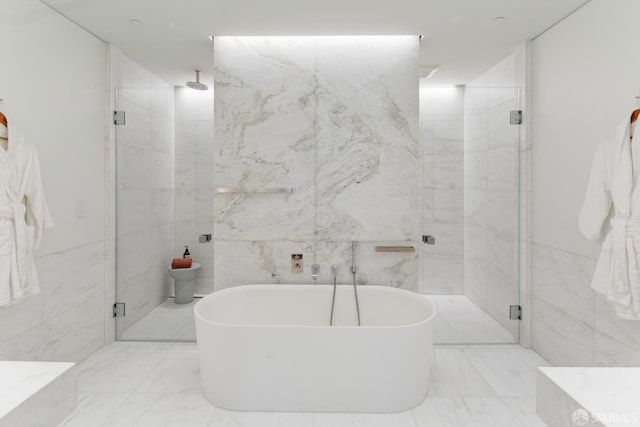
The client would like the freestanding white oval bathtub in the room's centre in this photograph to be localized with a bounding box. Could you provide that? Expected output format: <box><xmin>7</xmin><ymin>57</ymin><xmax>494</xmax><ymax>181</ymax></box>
<box><xmin>194</xmin><ymin>285</ymin><xmax>435</xmax><ymax>412</ymax></box>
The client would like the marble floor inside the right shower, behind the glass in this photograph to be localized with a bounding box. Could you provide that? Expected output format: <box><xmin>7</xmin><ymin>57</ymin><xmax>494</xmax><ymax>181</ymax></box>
<box><xmin>427</xmin><ymin>295</ymin><xmax>518</xmax><ymax>344</ymax></box>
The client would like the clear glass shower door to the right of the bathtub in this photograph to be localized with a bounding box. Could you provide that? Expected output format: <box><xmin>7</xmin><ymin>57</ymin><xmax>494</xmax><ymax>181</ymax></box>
<box><xmin>421</xmin><ymin>87</ymin><xmax>521</xmax><ymax>344</ymax></box>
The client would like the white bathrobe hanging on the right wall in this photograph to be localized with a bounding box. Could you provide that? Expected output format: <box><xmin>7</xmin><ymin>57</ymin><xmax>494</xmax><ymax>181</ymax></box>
<box><xmin>579</xmin><ymin>118</ymin><xmax>640</xmax><ymax>320</ymax></box>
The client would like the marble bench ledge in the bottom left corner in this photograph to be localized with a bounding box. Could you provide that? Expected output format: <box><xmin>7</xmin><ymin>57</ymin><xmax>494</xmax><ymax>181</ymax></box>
<box><xmin>0</xmin><ymin>361</ymin><xmax>77</xmax><ymax>427</ymax></box>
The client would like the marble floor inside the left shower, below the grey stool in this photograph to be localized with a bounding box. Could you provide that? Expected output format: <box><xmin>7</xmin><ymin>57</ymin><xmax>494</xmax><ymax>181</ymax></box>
<box><xmin>119</xmin><ymin>298</ymin><xmax>200</xmax><ymax>341</ymax></box>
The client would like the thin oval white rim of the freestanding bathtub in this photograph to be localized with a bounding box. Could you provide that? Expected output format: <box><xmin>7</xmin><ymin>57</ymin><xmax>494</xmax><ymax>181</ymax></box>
<box><xmin>193</xmin><ymin>283</ymin><xmax>436</xmax><ymax>330</ymax></box>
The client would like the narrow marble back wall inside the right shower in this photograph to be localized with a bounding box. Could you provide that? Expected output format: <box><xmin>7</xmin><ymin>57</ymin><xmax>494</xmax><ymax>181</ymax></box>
<box><xmin>420</xmin><ymin>87</ymin><xmax>464</xmax><ymax>294</ymax></box>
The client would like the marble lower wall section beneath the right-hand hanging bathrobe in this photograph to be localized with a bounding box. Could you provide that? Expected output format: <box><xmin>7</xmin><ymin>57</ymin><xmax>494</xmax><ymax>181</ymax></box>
<box><xmin>532</xmin><ymin>244</ymin><xmax>640</xmax><ymax>366</ymax></box>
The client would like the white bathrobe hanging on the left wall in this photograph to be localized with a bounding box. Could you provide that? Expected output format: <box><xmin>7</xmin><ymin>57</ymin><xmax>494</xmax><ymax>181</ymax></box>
<box><xmin>0</xmin><ymin>124</ymin><xmax>53</xmax><ymax>307</ymax></box>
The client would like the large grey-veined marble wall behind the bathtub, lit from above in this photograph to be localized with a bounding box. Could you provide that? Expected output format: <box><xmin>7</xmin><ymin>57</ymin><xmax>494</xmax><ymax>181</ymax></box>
<box><xmin>214</xmin><ymin>37</ymin><xmax>421</xmax><ymax>290</ymax></box>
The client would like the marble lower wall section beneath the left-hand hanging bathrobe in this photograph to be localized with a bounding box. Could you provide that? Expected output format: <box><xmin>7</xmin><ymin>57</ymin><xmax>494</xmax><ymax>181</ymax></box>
<box><xmin>0</xmin><ymin>242</ymin><xmax>106</xmax><ymax>361</ymax></box>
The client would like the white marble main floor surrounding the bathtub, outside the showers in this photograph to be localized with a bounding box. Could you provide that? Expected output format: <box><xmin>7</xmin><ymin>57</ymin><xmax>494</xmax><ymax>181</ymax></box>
<box><xmin>60</xmin><ymin>342</ymin><xmax>549</xmax><ymax>427</ymax></box>
